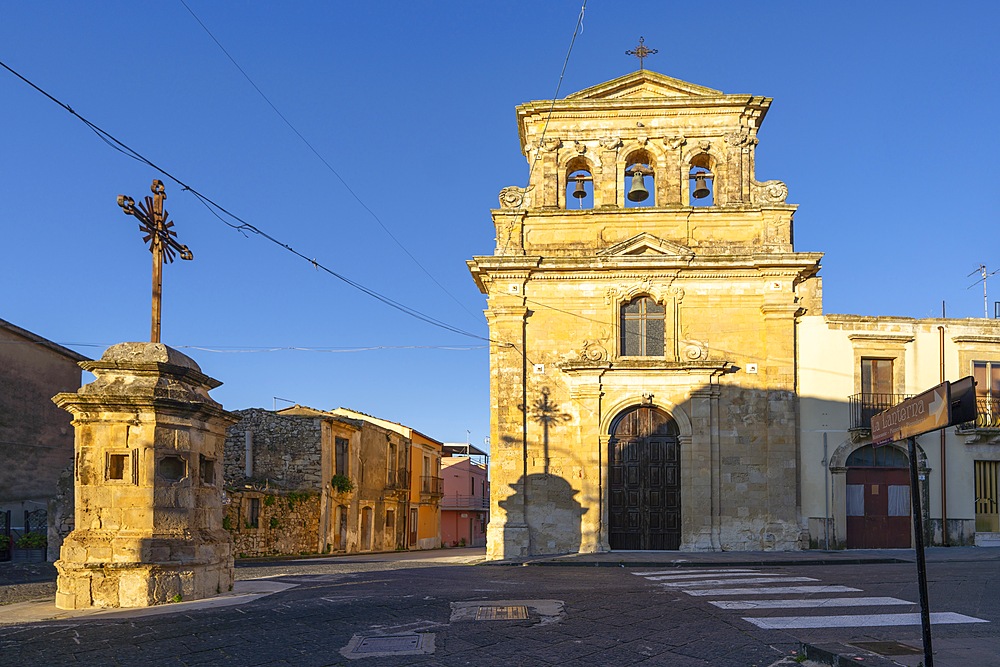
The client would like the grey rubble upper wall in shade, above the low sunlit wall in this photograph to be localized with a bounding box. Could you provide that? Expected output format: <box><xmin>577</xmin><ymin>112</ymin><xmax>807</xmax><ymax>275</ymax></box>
<box><xmin>224</xmin><ymin>408</ymin><xmax>329</xmax><ymax>491</ymax></box>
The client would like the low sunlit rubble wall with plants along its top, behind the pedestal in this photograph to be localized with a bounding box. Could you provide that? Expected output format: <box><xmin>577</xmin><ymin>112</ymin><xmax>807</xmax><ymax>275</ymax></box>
<box><xmin>223</xmin><ymin>491</ymin><xmax>320</xmax><ymax>558</ymax></box>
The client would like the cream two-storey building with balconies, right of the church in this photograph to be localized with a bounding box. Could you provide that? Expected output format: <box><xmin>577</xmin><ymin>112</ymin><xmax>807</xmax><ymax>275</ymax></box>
<box><xmin>798</xmin><ymin>315</ymin><xmax>1000</xmax><ymax>548</ymax></box>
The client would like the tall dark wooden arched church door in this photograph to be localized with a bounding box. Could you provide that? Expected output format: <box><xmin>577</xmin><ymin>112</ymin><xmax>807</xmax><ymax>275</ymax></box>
<box><xmin>608</xmin><ymin>406</ymin><xmax>681</xmax><ymax>550</ymax></box>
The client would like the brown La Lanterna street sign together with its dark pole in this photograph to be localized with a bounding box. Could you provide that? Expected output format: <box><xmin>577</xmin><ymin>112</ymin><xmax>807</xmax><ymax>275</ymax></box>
<box><xmin>871</xmin><ymin>376</ymin><xmax>976</xmax><ymax>667</ymax></box>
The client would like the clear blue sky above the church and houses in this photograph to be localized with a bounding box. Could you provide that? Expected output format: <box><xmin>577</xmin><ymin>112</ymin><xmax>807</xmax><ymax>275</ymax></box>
<box><xmin>0</xmin><ymin>0</ymin><xmax>1000</xmax><ymax>445</ymax></box>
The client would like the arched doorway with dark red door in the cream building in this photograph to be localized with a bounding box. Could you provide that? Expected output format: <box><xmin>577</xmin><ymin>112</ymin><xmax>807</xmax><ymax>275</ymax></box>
<box><xmin>847</xmin><ymin>445</ymin><xmax>911</xmax><ymax>549</ymax></box>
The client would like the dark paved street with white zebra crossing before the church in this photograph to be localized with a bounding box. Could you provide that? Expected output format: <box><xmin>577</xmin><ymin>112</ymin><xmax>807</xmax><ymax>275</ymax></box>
<box><xmin>0</xmin><ymin>549</ymin><xmax>1000</xmax><ymax>667</ymax></box>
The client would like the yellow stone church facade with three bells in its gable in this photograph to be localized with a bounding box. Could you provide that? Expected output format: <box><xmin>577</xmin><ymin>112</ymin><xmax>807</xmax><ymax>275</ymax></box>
<box><xmin>469</xmin><ymin>70</ymin><xmax>821</xmax><ymax>558</ymax></box>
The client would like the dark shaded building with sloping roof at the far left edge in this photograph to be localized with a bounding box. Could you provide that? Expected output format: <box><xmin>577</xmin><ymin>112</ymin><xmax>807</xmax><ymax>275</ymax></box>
<box><xmin>0</xmin><ymin>320</ymin><xmax>88</xmax><ymax>560</ymax></box>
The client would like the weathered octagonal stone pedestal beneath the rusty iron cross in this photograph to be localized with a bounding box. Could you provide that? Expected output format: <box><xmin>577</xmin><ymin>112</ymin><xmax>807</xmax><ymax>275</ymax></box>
<box><xmin>53</xmin><ymin>343</ymin><xmax>236</xmax><ymax>609</ymax></box>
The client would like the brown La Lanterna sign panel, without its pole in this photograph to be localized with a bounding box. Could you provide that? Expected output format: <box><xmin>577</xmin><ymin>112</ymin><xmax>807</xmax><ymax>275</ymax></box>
<box><xmin>871</xmin><ymin>376</ymin><xmax>976</xmax><ymax>445</ymax></box>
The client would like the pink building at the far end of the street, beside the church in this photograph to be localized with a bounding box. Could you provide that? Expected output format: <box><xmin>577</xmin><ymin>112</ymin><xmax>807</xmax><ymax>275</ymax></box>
<box><xmin>441</xmin><ymin>443</ymin><xmax>490</xmax><ymax>547</ymax></box>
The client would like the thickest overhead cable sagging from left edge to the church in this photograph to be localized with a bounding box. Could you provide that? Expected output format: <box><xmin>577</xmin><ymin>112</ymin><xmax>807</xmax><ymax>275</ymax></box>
<box><xmin>0</xmin><ymin>61</ymin><xmax>489</xmax><ymax>341</ymax></box>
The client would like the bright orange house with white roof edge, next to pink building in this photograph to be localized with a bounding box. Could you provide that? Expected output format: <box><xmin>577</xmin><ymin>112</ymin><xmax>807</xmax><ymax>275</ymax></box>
<box><xmin>330</xmin><ymin>408</ymin><xmax>443</xmax><ymax>549</ymax></box>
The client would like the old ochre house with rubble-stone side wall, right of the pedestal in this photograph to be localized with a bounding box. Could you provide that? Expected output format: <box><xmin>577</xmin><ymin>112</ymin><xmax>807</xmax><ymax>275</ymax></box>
<box><xmin>225</xmin><ymin>405</ymin><xmax>410</xmax><ymax>556</ymax></box>
